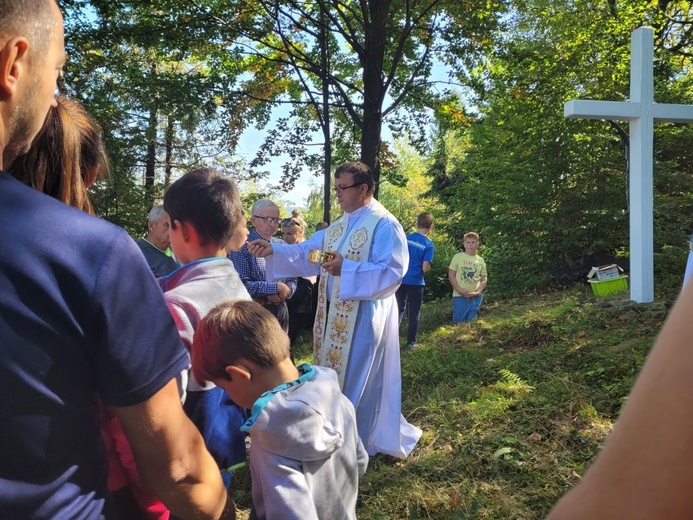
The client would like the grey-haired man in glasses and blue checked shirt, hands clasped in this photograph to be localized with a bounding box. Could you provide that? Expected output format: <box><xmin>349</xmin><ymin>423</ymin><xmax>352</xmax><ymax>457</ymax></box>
<box><xmin>229</xmin><ymin>199</ymin><xmax>296</xmax><ymax>333</ymax></box>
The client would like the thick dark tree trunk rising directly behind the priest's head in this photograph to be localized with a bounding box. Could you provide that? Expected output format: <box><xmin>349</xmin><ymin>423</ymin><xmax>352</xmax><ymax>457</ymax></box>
<box><xmin>361</xmin><ymin>0</ymin><xmax>390</xmax><ymax>198</ymax></box>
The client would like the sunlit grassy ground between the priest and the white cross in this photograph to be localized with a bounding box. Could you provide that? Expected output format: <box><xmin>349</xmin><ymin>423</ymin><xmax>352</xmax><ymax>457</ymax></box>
<box><xmin>234</xmin><ymin>287</ymin><xmax>669</xmax><ymax>520</ymax></box>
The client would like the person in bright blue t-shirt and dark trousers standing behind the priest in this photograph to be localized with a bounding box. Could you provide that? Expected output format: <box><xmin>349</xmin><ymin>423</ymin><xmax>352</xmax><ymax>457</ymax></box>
<box><xmin>395</xmin><ymin>211</ymin><xmax>435</xmax><ymax>350</ymax></box>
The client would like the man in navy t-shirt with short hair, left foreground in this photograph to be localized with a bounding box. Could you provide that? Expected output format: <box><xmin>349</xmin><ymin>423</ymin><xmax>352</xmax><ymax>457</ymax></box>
<box><xmin>0</xmin><ymin>0</ymin><xmax>235</xmax><ymax>519</ymax></box>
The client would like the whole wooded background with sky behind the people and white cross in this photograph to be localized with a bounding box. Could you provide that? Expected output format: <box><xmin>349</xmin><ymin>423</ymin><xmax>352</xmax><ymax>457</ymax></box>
<box><xmin>60</xmin><ymin>0</ymin><xmax>693</xmax><ymax>298</ymax></box>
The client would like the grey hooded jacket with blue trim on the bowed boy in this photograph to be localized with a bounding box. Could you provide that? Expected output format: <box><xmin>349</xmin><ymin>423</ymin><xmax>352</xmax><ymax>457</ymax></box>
<box><xmin>246</xmin><ymin>364</ymin><xmax>368</xmax><ymax>520</ymax></box>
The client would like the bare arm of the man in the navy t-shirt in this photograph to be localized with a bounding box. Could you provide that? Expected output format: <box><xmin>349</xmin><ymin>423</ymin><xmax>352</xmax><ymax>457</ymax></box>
<box><xmin>109</xmin><ymin>379</ymin><xmax>236</xmax><ymax>519</ymax></box>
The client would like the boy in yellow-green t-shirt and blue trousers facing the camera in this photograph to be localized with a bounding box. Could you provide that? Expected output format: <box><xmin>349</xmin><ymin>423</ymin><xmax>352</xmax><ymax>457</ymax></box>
<box><xmin>448</xmin><ymin>233</ymin><xmax>488</xmax><ymax>323</ymax></box>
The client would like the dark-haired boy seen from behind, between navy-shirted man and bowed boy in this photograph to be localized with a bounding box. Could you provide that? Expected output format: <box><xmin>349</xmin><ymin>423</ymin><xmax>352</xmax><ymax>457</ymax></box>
<box><xmin>159</xmin><ymin>168</ymin><xmax>250</xmax><ymax>486</ymax></box>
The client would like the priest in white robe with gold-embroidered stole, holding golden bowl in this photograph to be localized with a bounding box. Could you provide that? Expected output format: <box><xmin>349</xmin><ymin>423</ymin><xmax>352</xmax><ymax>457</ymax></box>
<box><xmin>248</xmin><ymin>163</ymin><xmax>421</xmax><ymax>458</ymax></box>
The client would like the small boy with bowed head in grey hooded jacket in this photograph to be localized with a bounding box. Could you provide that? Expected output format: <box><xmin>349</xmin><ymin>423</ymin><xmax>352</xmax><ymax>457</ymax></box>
<box><xmin>193</xmin><ymin>300</ymin><xmax>368</xmax><ymax>520</ymax></box>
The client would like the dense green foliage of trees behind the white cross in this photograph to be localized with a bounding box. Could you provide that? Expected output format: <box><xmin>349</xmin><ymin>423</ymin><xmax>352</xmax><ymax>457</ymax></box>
<box><xmin>430</xmin><ymin>0</ymin><xmax>693</xmax><ymax>294</ymax></box>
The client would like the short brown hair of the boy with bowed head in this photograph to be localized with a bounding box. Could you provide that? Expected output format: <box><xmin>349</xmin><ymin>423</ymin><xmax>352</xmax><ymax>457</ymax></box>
<box><xmin>192</xmin><ymin>300</ymin><xmax>289</xmax><ymax>381</ymax></box>
